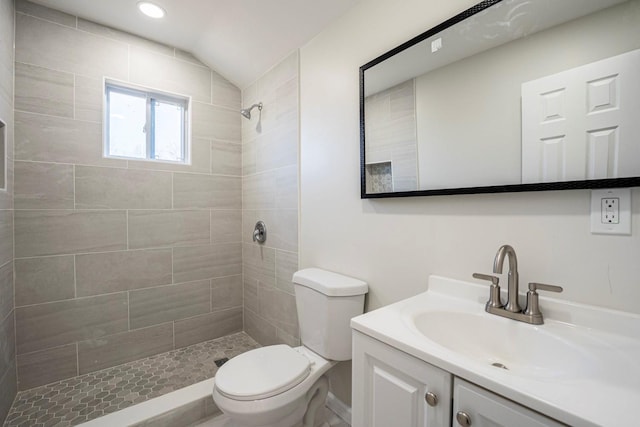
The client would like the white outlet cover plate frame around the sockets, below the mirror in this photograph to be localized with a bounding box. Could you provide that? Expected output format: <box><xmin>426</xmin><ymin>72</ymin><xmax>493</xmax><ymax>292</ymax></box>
<box><xmin>591</xmin><ymin>188</ymin><xmax>631</xmax><ymax>236</ymax></box>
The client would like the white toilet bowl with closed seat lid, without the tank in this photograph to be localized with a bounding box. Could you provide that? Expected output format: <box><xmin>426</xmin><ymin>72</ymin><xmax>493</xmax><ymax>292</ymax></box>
<box><xmin>213</xmin><ymin>345</ymin><xmax>337</xmax><ymax>427</ymax></box>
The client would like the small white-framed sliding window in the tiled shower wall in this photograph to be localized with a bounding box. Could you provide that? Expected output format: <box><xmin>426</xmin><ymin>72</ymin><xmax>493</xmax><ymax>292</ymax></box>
<box><xmin>105</xmin><ymin>81</ymin><xmax>189</xmax><ymax>163</ymax></box>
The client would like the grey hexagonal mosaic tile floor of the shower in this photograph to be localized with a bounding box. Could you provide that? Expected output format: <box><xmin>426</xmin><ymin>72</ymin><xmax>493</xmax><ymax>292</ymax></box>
<box><xmin>4</xmin><ymin>332</ymin><xmax>260</xmax><ymax>427</ymax></box>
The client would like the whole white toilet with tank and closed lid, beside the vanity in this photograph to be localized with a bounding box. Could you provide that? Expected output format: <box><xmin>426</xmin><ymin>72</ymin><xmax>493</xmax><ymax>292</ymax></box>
<box><xmin>213</xmin><ymin>268</ymin><xmax>368</xmax><ymax>427</ymax></box>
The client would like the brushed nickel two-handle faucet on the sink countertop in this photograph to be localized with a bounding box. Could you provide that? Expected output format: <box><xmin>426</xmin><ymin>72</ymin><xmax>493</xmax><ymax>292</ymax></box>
<box><xmin>473</xmin><ymin>245</ymin><xmax>562</xmax><ymax>325</ymax></box>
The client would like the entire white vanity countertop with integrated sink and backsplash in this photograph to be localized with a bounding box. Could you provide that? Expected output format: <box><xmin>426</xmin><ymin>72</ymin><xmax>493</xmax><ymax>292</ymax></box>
<box><xmin>351</xmin><ymin>276</ymin><xmax>640</xmax><ymax>427</ymax></box>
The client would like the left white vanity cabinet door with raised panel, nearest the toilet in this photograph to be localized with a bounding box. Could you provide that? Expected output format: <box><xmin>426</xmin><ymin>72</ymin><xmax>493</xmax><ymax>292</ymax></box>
<box><xmin>352</xmin><ymin>331</ymin><xmax>452</xmax><ymax>427</ymax></box>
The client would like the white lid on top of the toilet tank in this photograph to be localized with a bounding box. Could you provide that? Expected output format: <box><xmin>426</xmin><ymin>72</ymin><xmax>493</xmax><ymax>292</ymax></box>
<box><xmin>293</xmin><ymin>268</ymin><xmax>369</xmax><ymax>297</ymax></box>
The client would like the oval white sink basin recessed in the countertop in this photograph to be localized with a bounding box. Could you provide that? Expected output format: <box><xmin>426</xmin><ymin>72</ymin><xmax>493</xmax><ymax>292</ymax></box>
<box><xmin>411</xmin><ymin>311</ymin><xmax>594</xmax><ymax>379</ymax></box>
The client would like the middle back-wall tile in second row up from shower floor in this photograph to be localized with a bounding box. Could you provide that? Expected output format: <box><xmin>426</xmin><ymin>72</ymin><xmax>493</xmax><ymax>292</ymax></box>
<box><xmin>129</xmin><ymin>280</ymin><xmax>211</xmax><ymax>329</ymax></box>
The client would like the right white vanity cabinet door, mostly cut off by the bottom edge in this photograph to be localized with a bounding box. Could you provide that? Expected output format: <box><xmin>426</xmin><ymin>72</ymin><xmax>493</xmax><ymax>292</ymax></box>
<box><xmin>452</xmin><ymin>378</ymin><xmax>564</xmax><ymax>427</ymax></box>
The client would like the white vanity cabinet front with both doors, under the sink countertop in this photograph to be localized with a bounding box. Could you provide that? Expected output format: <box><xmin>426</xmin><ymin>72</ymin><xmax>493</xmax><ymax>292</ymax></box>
<box><xmin>352</xmin><ymin>330</ymin><xmax>564</xmax><ymax>427</ymax></box>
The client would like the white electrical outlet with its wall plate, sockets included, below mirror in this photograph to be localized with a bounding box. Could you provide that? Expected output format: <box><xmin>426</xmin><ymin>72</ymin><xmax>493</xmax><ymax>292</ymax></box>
<box><xmin>591</xmin><ymin>188</ymin><xmax>631</xmax><ymax>236</ymax></box>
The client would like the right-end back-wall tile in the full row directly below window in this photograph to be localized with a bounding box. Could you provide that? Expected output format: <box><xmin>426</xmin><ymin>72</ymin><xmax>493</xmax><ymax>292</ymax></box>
<box><xmin>173</xmin><ymin>173</ymin><xmax>242</xmax><ymax>209</ymax></box>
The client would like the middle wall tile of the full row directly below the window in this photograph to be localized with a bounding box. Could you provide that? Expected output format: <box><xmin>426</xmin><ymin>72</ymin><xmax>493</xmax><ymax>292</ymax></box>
<box><xmin>75</xmin><ymin>166</ymin><xmax>171</xmax><ymax>209</ymax></box>
